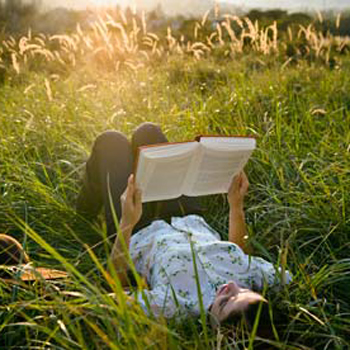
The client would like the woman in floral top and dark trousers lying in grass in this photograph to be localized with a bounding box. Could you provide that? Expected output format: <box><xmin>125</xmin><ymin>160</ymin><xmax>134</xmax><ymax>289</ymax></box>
<box><xmin>78</xmin><ymin>123</ymin><xmax>290</xmax><ymax>330</ymax></box>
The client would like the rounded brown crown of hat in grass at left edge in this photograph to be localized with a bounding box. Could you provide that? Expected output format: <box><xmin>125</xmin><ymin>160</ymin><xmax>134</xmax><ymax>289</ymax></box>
<box><xmin>0</xmin><ymin>234</ymin><xmax>30</xmax><ymax>265</ymax></box>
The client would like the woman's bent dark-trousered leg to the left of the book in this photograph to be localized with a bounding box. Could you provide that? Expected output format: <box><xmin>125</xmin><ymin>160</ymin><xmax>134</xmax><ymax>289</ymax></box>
<box><xmin>77</xmin><ymin>131</ymin><xmax>133</xmax><ymax>236</ymax></box>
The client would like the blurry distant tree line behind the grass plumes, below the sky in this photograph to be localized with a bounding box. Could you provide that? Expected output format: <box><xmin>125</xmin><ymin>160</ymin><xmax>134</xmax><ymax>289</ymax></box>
<box><xmin>0</xmin><ymin>0</ymin><xmax>350</xmax><ymax>36</ymax></box>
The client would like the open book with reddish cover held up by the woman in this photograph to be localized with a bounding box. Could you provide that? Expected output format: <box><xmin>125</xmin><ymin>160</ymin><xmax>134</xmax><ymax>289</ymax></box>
<box><xmin>135</xmin><ymin>136</ymin><xmax>256</xmax><ymax>203</ymax></box>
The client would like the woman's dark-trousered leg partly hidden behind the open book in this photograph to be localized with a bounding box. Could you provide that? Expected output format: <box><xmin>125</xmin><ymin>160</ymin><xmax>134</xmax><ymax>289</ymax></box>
<box><xmin>132</xmin><ymin>123</ymin><xmax>201</xmax><ymax>228</ymax></box>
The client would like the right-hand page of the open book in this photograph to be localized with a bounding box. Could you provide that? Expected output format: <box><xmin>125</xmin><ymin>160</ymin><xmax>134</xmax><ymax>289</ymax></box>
<box><xmin>185</xmin><ymin>137</ymin><xmax>256</xmax><ymax>196</ymax></box>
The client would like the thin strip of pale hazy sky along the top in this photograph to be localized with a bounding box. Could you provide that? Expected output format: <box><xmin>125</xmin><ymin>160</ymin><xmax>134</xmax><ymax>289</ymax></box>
<box><xmin>42</xmin><ymin>0</ymin><xmax>350</xmax><ymax>10</ymax></box>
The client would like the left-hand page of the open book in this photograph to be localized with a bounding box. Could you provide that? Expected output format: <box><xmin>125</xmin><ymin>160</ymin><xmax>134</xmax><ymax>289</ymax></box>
<box><xmin>136</xmin><ymin>142</ymin><xmax>199</xmax><ymax>203</ymax></box>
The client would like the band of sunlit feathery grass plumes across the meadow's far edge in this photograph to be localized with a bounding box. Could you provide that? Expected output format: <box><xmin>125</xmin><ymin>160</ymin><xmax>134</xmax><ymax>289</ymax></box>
<box><xmin>0</xmin><ymin>11</ymin><xmax>350</xmax><ymax>82</ymax></box>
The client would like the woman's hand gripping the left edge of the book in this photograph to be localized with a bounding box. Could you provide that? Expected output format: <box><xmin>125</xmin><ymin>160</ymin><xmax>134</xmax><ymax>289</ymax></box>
<box><xmin>120</xmin><ymin>175</ymin><xmax>142</xmax><ymax>228</ymax></box>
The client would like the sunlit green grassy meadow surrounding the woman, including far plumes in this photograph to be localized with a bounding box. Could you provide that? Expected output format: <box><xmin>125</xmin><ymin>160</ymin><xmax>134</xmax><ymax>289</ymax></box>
<box><xmin>0</xmin><ymin>8</ymin><xmax>350</xmax><ymax>350</ymax></box>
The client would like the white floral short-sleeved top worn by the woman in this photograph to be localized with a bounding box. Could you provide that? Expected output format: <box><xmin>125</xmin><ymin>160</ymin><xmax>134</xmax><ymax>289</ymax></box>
<box><xmin>130</xmin><ymin>215</ymin><xmax>291</xmax><ymax>318</ymax></box>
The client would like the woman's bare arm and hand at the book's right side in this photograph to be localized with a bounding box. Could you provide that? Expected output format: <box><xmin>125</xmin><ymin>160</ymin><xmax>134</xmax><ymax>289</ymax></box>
<box><xmin>227</xmin><ymin>171</ymin><xmax>250</xmax><ymax>254</ymax></box>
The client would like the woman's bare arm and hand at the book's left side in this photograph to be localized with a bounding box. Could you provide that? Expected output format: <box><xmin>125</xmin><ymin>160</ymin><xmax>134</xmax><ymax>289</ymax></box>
<box><xmin>111</xmin><ymin>175</ymin><xmax>142</xmax><ymax>287</ymax></box>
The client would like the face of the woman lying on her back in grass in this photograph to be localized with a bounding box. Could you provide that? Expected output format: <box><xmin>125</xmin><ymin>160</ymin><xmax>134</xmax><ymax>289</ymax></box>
<box><xmin>210</xmin><ymin>282</ymin><xmax>267</xmax><ymax>323</ymax></box>
